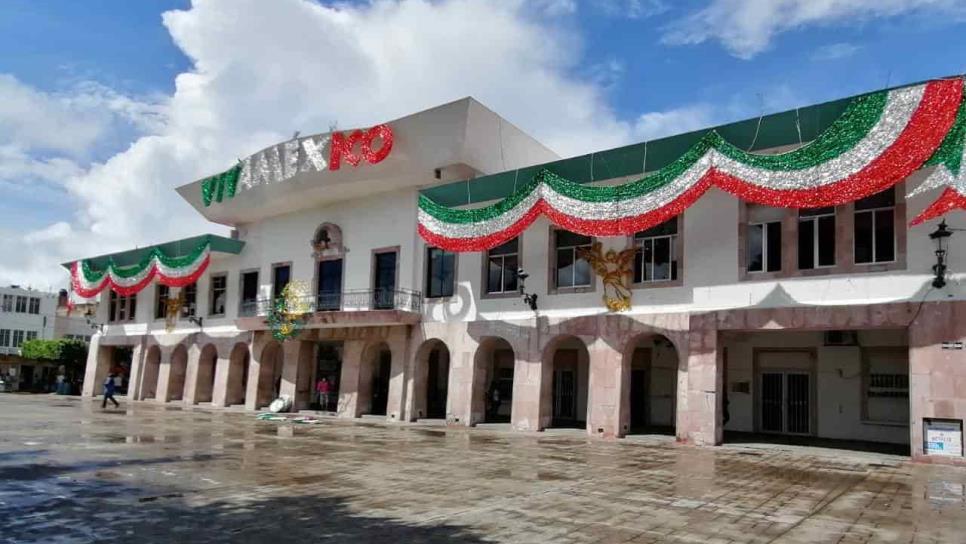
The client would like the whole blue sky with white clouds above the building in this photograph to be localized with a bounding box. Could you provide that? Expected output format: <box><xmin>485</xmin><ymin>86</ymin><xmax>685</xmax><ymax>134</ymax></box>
<box><xmin>0</xmin><ymin>0</ymin><xmax>966</xmax><ymax>289</ymax></box>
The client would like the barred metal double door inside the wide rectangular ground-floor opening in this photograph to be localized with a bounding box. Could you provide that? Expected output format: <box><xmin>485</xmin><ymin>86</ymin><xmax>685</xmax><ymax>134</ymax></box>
<box><xmin>761</xmin><ymin>371</ymin><xmax>812</xmax><ymax>434</ymax></box>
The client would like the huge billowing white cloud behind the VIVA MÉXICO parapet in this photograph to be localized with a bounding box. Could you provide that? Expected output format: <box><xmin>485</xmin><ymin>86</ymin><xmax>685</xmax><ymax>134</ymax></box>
<box><xmin>0</xmin><ymin>0</ymin><xmax>652</xmax><ymax>283</ymax></box>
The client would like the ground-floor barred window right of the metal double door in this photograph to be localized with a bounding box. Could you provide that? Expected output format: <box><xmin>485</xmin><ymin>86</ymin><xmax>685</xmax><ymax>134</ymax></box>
<box><xmin>863</xmin><ymin>348</ymin><xmax>909</xmax><ymax>423</ymax></box>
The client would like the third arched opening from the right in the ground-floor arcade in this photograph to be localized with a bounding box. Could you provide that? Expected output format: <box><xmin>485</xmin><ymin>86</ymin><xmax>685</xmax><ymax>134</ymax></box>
<box><xmin>473</xmin><ymin>337</ymin><xmax>516</xmax><ymax>423</ymax></box>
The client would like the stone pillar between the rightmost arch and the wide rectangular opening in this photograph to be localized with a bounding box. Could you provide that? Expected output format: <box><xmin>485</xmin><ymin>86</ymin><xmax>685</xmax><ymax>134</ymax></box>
<box><xmin>677</xmin><ymin>314</ymin><xmax>724</xmax><ymax>446</ymax></box>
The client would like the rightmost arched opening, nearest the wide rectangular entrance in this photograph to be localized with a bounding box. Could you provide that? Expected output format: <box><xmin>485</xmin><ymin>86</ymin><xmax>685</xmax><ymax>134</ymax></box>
<box><xmin>624</xmin><ymin>334</ymin><xmax>680</xmax><ymax>435</ymax></box>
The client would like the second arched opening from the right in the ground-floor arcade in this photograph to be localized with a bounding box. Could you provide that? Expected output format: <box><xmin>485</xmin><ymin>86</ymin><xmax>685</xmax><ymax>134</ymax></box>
<box><xmin>541</xmin><ymin>336</ymin><xmax>590</xmax><ymax>429</ymax></box>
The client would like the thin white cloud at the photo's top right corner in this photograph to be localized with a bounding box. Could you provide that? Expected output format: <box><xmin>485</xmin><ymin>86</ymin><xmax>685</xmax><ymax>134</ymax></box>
<box><xmin>663</xmin><ymin>0</ymin><xmax>966</xmax><ymax>59</ymax></box>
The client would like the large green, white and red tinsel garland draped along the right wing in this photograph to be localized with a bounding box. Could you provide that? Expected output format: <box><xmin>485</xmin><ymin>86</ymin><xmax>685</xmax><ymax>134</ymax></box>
<box><xmin>419</xmin><ymin>78</ymin><xmax>966</xmax><ymax>251</ymax></box>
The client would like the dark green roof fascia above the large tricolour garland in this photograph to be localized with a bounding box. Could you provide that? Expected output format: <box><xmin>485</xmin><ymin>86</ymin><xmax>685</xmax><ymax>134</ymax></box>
<box><xmin>421</xmin><ymin>76</ymin><xmax>958</xmax><ymax>207</ymax></box>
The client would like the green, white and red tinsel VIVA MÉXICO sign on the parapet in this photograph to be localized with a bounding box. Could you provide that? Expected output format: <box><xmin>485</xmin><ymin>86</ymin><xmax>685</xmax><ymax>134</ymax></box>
<box><xmin>201</xmin><ymin>124</ymin><xmax>393</xmax><ymax>206</ymax></box>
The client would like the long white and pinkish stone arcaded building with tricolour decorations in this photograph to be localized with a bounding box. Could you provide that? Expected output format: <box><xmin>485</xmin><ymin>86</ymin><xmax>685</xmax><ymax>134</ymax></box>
<box><xmin>67</xmin><ymin>79</ymin><xmax>966</xmax><ymax>462</ymax></box>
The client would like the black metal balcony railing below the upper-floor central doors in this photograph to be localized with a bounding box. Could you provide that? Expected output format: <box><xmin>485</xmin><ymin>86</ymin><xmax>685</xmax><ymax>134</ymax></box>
<box><xmin>239</xmin><ymin>289</ymin><xmax>423</xmax><ymax>317</ymax></box>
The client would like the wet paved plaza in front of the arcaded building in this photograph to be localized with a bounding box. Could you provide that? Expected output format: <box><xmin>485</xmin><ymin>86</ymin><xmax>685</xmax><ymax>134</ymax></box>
<box><xmin>0</xmin><ymin>394</ymin><xmax>966</xmax><ymax>544</ymax></box>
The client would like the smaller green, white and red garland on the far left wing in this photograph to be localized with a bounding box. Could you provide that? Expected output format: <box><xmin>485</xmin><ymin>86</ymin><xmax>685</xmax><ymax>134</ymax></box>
<box><xmin>70</xmin><ymin>241</ymin><xmax>211</xmax><ymax>298</ymax></box>
